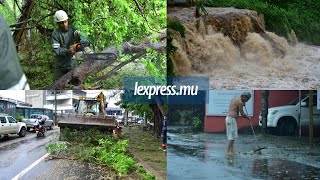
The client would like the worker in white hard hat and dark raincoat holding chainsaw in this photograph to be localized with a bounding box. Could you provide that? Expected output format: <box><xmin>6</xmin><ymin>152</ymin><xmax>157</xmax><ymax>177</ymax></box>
<box><xmin>52</xmin><ymin>10</ymin><xmax>89</xmax><ymax>81</ymax></box>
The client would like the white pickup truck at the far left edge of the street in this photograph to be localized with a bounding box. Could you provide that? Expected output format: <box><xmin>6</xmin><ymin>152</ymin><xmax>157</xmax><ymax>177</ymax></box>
<box><xmin>0</xmin><ymin>114</ymin><xmax>27</xmax><ymax>137</ymax></box>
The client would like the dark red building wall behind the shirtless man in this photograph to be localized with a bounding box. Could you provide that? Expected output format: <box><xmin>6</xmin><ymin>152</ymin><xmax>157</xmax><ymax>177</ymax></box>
<box><xmin>204</xmin><ymin>90</ymin><xmax>308</xmax><ymax>132</ymax></box>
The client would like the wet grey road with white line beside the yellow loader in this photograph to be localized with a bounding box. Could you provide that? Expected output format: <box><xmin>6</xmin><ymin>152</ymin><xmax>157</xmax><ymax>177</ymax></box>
<box><xmin>0</xmin><ymin>127</ymin><xmax>106</xmax><ymax>180</ymax></box>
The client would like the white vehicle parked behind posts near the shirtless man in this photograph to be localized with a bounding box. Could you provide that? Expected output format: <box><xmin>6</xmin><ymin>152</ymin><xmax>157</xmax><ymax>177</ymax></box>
<box><xmin>259</xmin><ymin>94</ymin><xmax>320</xmax><ymax>136</ymax></box>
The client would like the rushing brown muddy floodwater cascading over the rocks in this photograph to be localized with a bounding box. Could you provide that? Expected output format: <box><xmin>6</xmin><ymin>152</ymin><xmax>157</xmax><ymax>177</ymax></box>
<box><xmin>168</xmin><ymin>8</ymin><xmax>320</xmax><ymax>89</ymax></box>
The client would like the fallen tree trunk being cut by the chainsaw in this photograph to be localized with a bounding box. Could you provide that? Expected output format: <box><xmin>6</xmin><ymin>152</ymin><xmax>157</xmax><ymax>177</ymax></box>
<box><xmin>44</xmin><ymin>30</ymin><xmax>166</xmax><ymax>89</ymax></box>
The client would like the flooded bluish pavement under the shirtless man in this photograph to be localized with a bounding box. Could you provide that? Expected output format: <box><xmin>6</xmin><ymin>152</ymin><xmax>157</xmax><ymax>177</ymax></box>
<box><xmin>167</xmin><ymin>127</ymin><xmax>320</xmax><ymax>180</ymax></box>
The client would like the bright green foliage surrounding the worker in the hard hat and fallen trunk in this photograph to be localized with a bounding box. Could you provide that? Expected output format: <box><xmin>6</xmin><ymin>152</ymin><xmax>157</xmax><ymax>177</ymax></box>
<box><xmin>0</xmin><ymin>0</ymin><xmax>166</xmax><ymax>89</ymax></box>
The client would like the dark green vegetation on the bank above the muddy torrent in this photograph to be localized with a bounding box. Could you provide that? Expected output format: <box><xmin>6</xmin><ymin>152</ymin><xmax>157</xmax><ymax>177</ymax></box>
<box><xmin>205</xmin><ymin>0</ymin><xmax>320</xmax><ymax>45</ymax></box>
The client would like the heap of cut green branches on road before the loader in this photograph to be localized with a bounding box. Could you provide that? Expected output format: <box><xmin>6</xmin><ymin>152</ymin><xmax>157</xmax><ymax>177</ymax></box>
<box><xmin>46</xmin><ymin>128</ymin><xmax>154</xmax><ymax>179</ymax></box>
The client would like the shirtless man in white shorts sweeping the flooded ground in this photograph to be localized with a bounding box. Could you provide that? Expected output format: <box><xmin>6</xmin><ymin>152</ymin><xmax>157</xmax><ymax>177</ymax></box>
<box><xmin>226</xmin><ymin>92</ymin><xmax>251</xmax><ymax>156</ymax></box>
